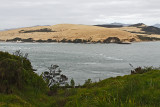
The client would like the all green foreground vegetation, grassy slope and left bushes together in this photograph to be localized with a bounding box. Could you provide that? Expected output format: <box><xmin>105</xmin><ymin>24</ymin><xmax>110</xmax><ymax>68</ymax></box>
<box><xmin>0</xmin><ymin>52</ymin><xmax>160</xmax><ymax>107</ymax></box>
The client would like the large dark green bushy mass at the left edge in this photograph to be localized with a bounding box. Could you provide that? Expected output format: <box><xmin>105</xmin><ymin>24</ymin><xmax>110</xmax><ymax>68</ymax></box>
<box><xmin>0</xmin><ymin>52</ymin><xmax>47</xmax><ymax>93</ymax></box>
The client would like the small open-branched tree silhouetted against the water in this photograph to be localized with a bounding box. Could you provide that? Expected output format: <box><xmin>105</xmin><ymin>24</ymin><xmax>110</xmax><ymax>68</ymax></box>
<box><xmin>42</xmin><ymin>64</ymin><xmax>68</xmax><ymax>87</ymax></box>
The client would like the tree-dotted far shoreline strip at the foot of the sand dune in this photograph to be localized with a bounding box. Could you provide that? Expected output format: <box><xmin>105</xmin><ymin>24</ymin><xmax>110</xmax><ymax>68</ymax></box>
<box><xmin>0</xmin><ymin>37</ymin><xmax>160</xmax><ymax>45</ymax></box>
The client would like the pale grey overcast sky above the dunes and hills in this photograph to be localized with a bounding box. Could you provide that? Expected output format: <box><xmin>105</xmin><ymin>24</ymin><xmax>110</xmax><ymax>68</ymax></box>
<box><xmin>0</xmin><ymin>0</ymin><xmax>160</xmax><ymax>30</ymax></box>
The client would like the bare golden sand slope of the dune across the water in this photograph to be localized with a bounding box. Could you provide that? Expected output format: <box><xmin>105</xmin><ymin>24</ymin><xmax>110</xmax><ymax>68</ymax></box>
<box><xmin>0</xmin><ymin>24</ymin><xmax>139</xmax><ymax>41</ymax></box>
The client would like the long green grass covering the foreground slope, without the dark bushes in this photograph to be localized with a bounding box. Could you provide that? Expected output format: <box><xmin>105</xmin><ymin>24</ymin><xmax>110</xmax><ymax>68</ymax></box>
<box><xmin>0</xmin><ymin>70</ymin><xmax>160</xmax><ymax>107</ymax></box>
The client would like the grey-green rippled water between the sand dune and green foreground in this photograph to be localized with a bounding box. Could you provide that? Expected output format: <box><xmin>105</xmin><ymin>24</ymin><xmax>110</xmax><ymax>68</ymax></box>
<box><xmin>0</xmin><ymin>42</ymin><xmax>160</xmax><ymax>84</ymax></box>
